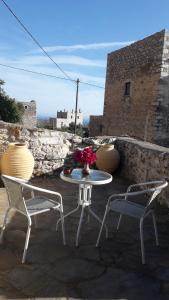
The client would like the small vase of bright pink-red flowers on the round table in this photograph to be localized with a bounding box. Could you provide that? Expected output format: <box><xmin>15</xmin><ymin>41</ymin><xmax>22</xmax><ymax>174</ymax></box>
<box><xmin>75</xmin><ymin>147</ymin><xmax>96</xmax><ymax>175</ymax></box>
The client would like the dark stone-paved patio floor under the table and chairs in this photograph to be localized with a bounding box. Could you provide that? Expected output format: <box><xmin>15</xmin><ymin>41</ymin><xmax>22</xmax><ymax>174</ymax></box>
<box><xmin>0</xmin><ymin>176</ymin><xmax>169</xmax><ymax>300</ymax></box>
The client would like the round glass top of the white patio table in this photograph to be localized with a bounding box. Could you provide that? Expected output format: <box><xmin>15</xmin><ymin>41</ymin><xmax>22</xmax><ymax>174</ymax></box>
<box><xmin>60</xmin><ymin>168</ymin><xmax>113</xmax><ymax>185</ymax></box>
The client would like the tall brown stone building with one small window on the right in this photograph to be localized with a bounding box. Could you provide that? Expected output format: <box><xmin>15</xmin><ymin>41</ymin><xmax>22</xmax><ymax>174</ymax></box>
<box><xmin>90</xmin><ymin>30</ymin><xmax>169</xmax><ymax>145</ymax></box>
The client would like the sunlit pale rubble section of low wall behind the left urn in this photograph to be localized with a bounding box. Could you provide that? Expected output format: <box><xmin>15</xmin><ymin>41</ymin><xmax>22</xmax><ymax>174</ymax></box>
<box><xmin>0</xmin><ymin>121</ymin><xmax>81</xmax><ymax>176</ymax></box>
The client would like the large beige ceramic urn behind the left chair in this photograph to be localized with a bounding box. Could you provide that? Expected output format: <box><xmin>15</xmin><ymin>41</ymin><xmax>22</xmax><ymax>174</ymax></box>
<box><xmin>1</xmin><ymin>143</ymin><xmax>34</xmax><ymax>180</ymax></box>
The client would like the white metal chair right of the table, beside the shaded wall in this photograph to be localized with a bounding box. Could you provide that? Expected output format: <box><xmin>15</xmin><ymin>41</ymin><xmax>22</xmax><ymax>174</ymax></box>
<box><xmin>96</xmin><ymin>180</ymin><xmax>168</xmax><ymax>264</ymax></box>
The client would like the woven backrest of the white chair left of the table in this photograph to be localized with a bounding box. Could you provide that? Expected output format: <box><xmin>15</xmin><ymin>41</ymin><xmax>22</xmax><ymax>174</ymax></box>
<box><xmin>1</xmin><ymin>175</ymin><xmax>28</xmax><ymax>215</ymax></box>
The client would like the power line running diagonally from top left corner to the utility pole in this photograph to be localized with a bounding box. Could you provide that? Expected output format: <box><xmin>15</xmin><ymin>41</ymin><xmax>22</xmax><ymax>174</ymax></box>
<box><xmin>1</xmin><ymin>0</ymin><xmax>73</xmax><ymax>81</ymax></box>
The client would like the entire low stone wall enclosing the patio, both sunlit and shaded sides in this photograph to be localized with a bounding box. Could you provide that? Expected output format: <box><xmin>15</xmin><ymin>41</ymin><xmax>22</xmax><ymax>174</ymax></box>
<box><xmin>0</xmin><ymin>122</ymin><xmax>169</xmax><ymax>206</ymax></box>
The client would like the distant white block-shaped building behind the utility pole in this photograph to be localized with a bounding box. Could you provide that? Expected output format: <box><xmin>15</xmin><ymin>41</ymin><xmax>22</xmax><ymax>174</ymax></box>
<box><xmin>49</xmin><ymin>109</ymin><xmax>83</xmax><ymax>129</ymax></box>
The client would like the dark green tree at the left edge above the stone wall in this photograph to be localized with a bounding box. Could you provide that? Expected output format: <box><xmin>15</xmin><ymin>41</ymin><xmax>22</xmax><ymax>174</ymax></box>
<box><xmin>0</xmin><ymin>79</ymin><xmax>24</xmax><ymax>123</ymax></box>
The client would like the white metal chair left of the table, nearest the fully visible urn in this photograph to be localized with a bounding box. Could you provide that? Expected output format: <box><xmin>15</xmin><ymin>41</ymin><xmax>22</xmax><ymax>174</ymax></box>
<box><xmin>0</xmin><ymin>175</ymin><xmax>66</xmax><ymax>263</ymax></box>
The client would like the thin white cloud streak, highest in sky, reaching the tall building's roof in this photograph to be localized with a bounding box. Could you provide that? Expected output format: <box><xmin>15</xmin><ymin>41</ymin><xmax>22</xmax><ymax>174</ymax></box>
<box><xmin>34</xmin><ymin>41</ymin><xmax>134</xmax><ymax>53</ymax></box>
